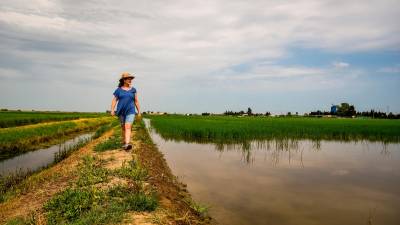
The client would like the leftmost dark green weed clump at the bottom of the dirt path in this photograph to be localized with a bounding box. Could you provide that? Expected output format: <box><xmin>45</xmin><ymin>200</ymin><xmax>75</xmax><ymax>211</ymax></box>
<box><xmin>43</xmin><ymin>188</ymin><xmax>104</xmax><ymax>225</ymax></box>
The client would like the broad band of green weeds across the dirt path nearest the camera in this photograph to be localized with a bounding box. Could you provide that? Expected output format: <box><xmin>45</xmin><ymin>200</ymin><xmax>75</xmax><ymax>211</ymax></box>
<box><xmin>43</xmin><ymin>185</ymin><xmax>158</xmax><ymax>225</ymax></box>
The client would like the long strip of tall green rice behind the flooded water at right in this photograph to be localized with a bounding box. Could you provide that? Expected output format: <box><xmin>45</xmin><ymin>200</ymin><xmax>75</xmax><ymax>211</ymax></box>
<box><xmin>147</xmin><ymin>115</ymin><xmax>400</xmax><ymax>143</ymax></box>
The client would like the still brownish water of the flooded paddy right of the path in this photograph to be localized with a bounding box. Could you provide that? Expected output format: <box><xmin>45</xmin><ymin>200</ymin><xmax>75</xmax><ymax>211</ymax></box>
<box><xmin>144</xmin><ymin>119</ymin><xmax>400</xmax><ymax>225</ymax></box>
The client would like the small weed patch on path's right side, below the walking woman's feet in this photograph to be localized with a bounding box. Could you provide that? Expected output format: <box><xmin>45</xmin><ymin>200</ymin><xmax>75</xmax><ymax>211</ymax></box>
<box><xmin>114</xmin><ymin>160</ymin><xmax>148</xmax><ymax>181</ymax></box>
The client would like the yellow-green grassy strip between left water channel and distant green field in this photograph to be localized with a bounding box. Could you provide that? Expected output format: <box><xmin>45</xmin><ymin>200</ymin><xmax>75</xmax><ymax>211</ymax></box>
<box><xmin>0</xmin><ymin>117</ymin><xmax>115</xmax><ymax>159</ymax></box>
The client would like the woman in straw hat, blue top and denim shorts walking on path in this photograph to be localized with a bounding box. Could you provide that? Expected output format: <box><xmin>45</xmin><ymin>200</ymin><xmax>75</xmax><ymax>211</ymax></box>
<box><xmin>111</xmin><ymin>72</ymin><xmax>140</xmax><ymax>150</ymax></box>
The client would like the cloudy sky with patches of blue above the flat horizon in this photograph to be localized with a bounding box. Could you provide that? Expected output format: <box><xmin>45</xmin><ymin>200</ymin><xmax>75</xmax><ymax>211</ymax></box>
<box><xmin>0</xmin><ymin>0</ymin><xmax>400</xmax><ymax>113</ymax></box>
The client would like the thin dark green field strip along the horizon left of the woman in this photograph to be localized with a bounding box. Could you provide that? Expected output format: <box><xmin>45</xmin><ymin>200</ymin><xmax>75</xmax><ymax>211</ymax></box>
<box><xmin>0</xmin><ymin>111</ymin><xmax>107</xmax><ymax>128</ymax></box>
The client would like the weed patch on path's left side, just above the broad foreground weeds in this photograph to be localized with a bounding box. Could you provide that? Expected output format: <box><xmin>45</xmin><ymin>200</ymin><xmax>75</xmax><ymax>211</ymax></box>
<box><xmin>77</xmin><ymin>156</ymin><xmax>109</xmax><ymax>187</ymax></box>
